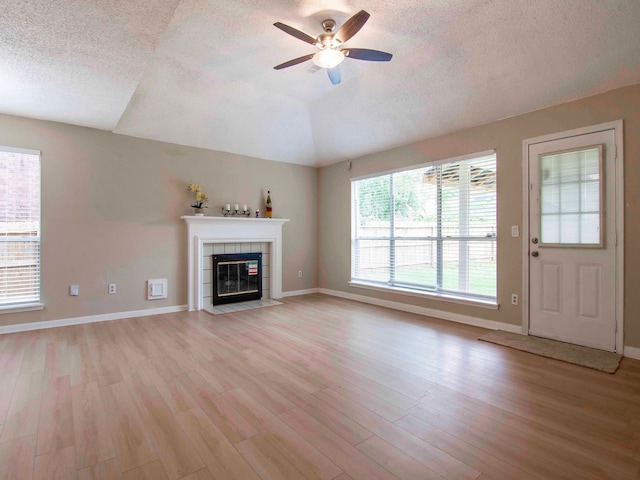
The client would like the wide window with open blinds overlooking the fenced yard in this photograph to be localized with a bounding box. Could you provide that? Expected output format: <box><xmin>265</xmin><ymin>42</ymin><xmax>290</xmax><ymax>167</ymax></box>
<box><xmin>351</xmin><ymin>152</ymin><xmax>497</xmax><ymax>303</ymax></box>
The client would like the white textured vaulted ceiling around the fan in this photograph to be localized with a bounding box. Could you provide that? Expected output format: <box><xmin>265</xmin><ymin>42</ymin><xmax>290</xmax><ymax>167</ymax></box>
<box><xmin>0</xmin><ymin>0</ymin><xmax>640</xmax><ymax>166</ymax></box>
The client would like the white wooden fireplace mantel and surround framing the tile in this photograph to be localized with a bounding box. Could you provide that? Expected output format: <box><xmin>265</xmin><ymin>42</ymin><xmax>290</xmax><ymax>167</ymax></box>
<box><xmin>180</xmin><ymin>215</ymin><xmax>289</xmax><ymax>311</ymax></box>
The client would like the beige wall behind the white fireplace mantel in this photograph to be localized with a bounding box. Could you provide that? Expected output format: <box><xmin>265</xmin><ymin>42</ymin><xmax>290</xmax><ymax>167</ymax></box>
<box><xmin>0</xmin><ymin>115</ymin><xmax>318</xmax><ymax>325</ymax></box>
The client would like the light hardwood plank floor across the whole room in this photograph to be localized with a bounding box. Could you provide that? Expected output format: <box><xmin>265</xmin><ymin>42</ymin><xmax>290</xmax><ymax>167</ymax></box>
<box><xmin>0</xmin><ymin>295</ymin><xmax>640</xmax><ymax>480</ymax></box>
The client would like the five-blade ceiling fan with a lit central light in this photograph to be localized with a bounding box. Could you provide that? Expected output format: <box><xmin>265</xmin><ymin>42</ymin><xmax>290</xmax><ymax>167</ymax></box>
<box><xmin>273</xmin><ymin>10</ymin><xmax>393</xmax><ymax>85</ymax></box>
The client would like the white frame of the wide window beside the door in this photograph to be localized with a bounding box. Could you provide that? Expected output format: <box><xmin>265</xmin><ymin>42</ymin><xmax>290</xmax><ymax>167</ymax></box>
<box><xmin>349</xmin><ymin>150</ymin><xmax>498</xmax><ymax>309</ymax></box>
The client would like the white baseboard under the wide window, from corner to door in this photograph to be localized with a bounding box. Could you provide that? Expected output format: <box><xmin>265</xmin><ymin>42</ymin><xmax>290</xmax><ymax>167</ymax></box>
<box><xmin>319</xmin><ymin>288</ymin><xmax>522</xmax><ymax>333</ymax></box>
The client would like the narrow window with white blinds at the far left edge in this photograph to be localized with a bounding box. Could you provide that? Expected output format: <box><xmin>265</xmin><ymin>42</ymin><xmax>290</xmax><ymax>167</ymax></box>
<box><xmin>0</xmin><ymin>147</ymin><xmax>40</xmax><ymax>311</ymax></box>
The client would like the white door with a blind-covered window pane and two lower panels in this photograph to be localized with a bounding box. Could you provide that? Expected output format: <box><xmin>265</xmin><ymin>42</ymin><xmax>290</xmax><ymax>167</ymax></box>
<box><xmin>528</xmin><ymin>130</ymin><xmax>616</xmax><ymax>351</ymax></box>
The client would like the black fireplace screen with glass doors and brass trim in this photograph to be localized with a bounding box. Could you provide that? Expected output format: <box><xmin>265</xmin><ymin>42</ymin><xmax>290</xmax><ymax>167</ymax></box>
<box><xmin>213</xmin><ymin>253</ymin><xmax>262</xmax><ymax>305</ymax></box>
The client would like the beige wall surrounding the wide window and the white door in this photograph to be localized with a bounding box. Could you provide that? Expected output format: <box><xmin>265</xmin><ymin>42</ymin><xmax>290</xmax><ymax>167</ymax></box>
<box><xmin>318</xmin><ymin>85</ymin><xmax>640</xmax><ymax>347</ymax></box>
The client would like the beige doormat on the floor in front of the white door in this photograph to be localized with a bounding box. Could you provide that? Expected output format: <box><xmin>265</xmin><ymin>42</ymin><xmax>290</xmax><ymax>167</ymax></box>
<box><xmin>478</xmin><ymin>330</ymin><xmax>622</xmax><ymax>373</ymax></box>
